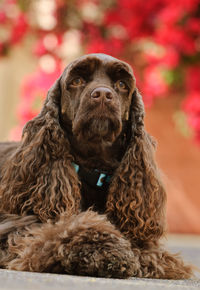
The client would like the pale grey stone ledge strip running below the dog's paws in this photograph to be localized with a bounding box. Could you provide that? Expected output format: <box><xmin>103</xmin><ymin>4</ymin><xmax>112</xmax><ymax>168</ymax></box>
<box><xmin>0</xmin><ymin>270</ymin><xmax>200</xmax><ymax>290</ymax></box>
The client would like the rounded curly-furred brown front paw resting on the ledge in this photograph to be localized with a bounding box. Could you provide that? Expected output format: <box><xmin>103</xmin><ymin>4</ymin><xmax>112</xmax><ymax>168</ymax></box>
<box><xmin>59</xmin><ymin>229</ymin><xmax>137</xmax><ymax>278</ymax></box>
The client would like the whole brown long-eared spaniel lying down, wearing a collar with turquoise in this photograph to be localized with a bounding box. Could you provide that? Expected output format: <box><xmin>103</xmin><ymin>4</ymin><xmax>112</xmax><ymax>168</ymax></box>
<box><xmin>0</xmin><ymin>54</ymin><xmax>192</xmax><ymax>279</ymax></box>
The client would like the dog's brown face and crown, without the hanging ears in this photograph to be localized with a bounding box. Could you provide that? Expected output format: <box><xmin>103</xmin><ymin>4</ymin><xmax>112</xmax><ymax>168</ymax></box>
<box><xmin>60</xmin><ymin>54</ymin><xmax>135</xmax><ymax>143</ymax></box>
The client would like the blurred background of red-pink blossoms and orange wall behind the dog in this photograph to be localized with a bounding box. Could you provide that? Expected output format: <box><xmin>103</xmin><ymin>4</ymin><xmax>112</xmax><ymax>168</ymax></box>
<box><xmin>0</xmin><ymin>0</ymin><xmax>200</xmax><ymax>234</ymax></box>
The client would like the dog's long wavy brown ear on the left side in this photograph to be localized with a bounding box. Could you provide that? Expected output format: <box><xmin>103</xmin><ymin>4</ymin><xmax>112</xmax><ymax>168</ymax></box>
<box><xmin>0</xmin><ymin>79</ymin><xmax>80</xmax><ymax>221</ymax></box>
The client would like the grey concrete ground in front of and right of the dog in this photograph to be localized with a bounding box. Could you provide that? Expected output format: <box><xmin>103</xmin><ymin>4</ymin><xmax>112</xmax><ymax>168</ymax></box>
<box><xmin>0</xmin><ymin>235</ymin><xmax>200</xmax><ymax>290</ymax></box>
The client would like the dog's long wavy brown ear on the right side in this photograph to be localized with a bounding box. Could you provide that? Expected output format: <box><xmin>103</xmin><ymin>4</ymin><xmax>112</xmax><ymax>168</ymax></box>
<box><xmin>107</xmin><ymin>89</ymin><xmax>166</xmax><ymax>246</ymax></box>
